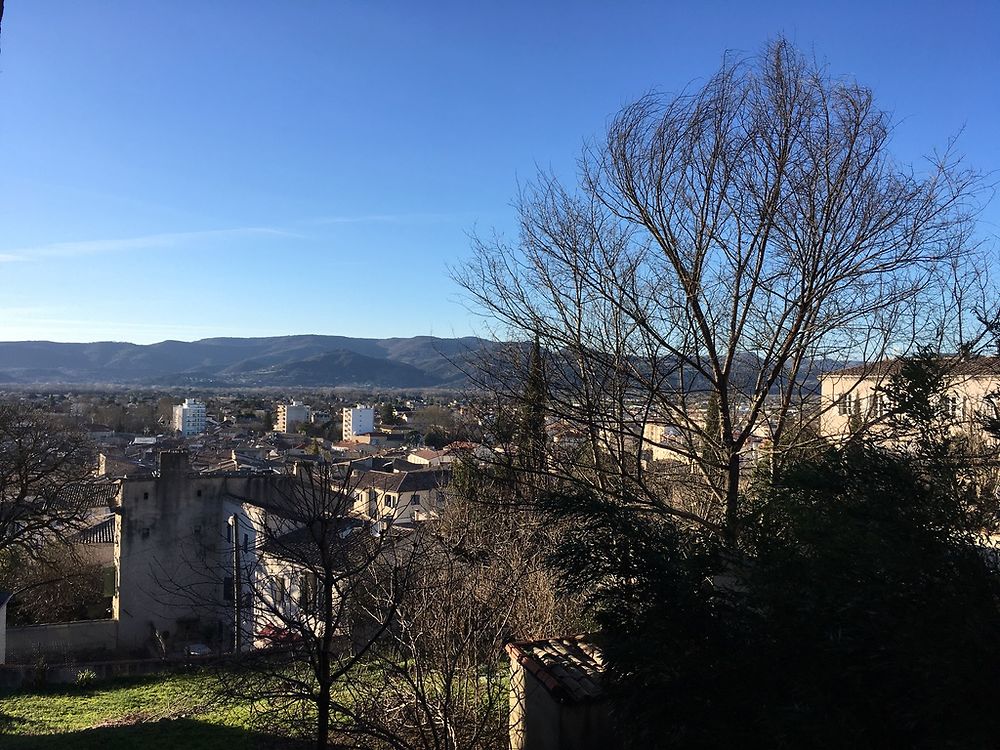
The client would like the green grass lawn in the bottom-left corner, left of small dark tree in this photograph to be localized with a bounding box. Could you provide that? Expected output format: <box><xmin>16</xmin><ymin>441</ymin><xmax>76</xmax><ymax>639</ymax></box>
<box><xmin>0</xmin><ymin>673</ymin><xmax>292</xmax><ymax>750</ymax></box>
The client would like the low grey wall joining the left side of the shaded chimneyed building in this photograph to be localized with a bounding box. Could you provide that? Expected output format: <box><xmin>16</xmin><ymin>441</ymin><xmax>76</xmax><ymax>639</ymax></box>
<box><xmin>6</xmin><ymin>620</ymin><xmax>118</xmax><ymax>664</ymax></box>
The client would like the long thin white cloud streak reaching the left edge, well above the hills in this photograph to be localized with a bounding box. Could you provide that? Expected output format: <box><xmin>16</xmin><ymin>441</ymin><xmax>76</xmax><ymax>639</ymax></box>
<box><xmin>0</xmin><ymin>227</ymin><xmax>302</xmax><ymax>262</ymax></box>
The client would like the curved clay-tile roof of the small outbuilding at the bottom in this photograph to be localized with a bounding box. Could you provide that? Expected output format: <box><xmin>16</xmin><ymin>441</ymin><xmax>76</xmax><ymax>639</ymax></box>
<box><xmin>507</xmin><ymin>636</ymin><xmax>604</xmax><ymax>703</ymax></box>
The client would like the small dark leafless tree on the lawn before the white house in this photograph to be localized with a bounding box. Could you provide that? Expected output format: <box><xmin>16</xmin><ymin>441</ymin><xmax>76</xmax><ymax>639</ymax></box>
<box><xmin>205</xmin><ymin>463</ymin><xmax>400</xmax><ymax>748</ymax></box>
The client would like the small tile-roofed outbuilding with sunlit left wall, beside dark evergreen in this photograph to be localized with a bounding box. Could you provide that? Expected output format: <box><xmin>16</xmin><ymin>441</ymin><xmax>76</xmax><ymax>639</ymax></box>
<box><xmin>507</xmin><ymin>636</ymin><xmax>622</xmax><ymax>750</ymax></box>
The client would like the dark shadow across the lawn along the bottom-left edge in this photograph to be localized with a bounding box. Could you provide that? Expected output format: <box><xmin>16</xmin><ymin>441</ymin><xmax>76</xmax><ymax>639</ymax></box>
<box><xmin>0</xmin><ymin>719</ymin><xmax>312</xmax><ymax>750</ymax></box>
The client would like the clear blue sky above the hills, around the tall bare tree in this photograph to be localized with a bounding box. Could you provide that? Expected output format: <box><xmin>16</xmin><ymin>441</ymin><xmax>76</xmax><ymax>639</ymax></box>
<box><xmin>0</xmin><ymin>0</ymin><xmax>1000</xmax><ymax>343</ymax></box>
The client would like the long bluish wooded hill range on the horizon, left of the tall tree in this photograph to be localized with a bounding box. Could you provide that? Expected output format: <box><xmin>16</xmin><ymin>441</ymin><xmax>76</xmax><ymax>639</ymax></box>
<box><xmin>0</xmin><ymin>335</ymin><xmax>495</xmax><ymax>388</ymax></box>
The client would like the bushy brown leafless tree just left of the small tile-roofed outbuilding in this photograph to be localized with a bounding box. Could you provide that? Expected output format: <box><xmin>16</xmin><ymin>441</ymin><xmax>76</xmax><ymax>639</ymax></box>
<box><xmin>330</xmin><ymin>487</ymin><xmax>576</xmax><ymax>750</ymax></box>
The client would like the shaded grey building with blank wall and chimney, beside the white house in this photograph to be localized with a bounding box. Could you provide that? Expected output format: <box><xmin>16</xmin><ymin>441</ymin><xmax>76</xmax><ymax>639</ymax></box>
<box><xmin>112</xmin><ymin>451</ymin><xmax>276</xmax><ymax>651</ymax></box>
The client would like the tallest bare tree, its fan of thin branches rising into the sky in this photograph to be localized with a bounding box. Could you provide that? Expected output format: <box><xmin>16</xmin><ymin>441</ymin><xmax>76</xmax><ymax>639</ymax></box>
<box><xmin>457</xmin><ymin>39</ymin><xmax>991</xmax><ymax>543</ymax></box>
